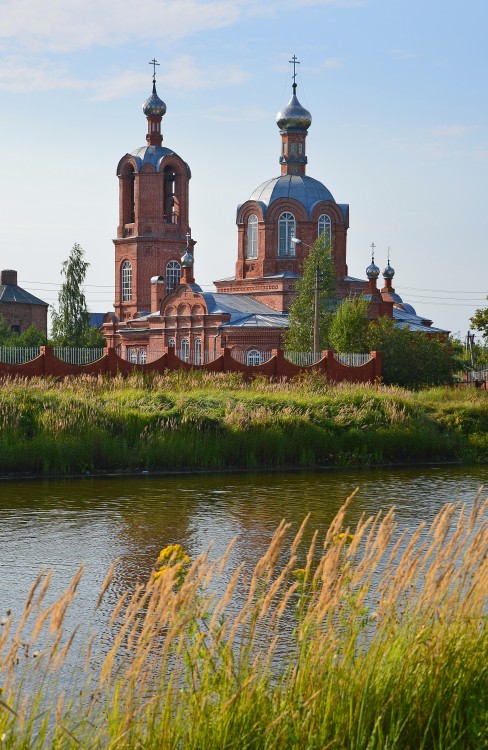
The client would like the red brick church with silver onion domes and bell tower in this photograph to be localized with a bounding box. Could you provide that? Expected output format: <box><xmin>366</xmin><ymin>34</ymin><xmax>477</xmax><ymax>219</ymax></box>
<box><xmin>102</xmin><ymin>61</ymin><xmax>446</xmax><ymax>364</ymax></box>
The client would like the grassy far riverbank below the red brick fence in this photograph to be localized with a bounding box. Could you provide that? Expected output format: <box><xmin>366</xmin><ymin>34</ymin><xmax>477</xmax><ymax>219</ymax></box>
<box><xmin>0</xmin><ymin>372</ymin><xmax>488</xmax><ymax>476</ymax></box>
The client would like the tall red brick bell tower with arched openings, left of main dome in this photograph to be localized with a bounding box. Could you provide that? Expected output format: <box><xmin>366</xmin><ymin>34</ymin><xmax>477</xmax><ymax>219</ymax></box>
<box><xmin>114</xmin><ymin>60</ymin><xmax>194</xmax><ymax>321</ymax></box>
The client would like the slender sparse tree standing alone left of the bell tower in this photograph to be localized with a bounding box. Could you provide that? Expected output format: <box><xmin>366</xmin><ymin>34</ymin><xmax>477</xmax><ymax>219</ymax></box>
<box><xmin>51</xmin><ymin>242</ymin><xmax>105</xmax><ymax>346</ymax></box>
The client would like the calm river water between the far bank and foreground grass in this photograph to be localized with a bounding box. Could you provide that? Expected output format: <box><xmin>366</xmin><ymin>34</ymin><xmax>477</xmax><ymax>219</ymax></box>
<box><xmin>0</xmin><ymin>467</ymin><xmax>488</xmax><ymax>625</ymax></box>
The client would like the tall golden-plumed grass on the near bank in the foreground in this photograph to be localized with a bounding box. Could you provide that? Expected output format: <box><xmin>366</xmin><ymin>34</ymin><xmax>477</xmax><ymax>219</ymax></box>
<box><xmin>0</xmin><ymin>497</ymin><xmax>488</xmax><ymax>750</ymax></box>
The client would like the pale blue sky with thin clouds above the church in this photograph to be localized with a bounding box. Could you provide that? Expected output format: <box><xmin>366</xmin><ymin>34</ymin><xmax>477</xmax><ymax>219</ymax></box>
<box><xmin>0</xmin><ymin>0</ymin><xmax>488</xmax><ymax>338</ymax></box>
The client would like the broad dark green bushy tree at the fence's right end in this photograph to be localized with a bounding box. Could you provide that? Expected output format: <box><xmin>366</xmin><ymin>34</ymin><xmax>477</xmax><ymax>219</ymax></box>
<box><xmin>369</xmin><ymin>318</ymin><xmax>459</xmax><ymax>388</ymax></box>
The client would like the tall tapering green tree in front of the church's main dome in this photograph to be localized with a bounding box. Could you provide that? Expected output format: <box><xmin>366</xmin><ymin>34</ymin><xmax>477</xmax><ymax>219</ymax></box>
<box><xmin>286</xmin><ymin>234</ymin><xmax>337</xmax><ymax>352</ymax></box>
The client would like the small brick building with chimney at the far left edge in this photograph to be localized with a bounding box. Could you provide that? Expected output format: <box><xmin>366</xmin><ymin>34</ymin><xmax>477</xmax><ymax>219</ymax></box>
<box><xmin>0</xmin><ymin>270</ymin><xmax>49</xmax><ymax>336</ymax></box>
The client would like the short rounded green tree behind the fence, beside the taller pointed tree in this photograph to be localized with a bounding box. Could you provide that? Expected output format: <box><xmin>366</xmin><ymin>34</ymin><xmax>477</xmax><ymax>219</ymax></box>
<box><xmin>329</xmin><ymin>297</ymin><xmax>370</xmax><ymax>352</ymax></box>
